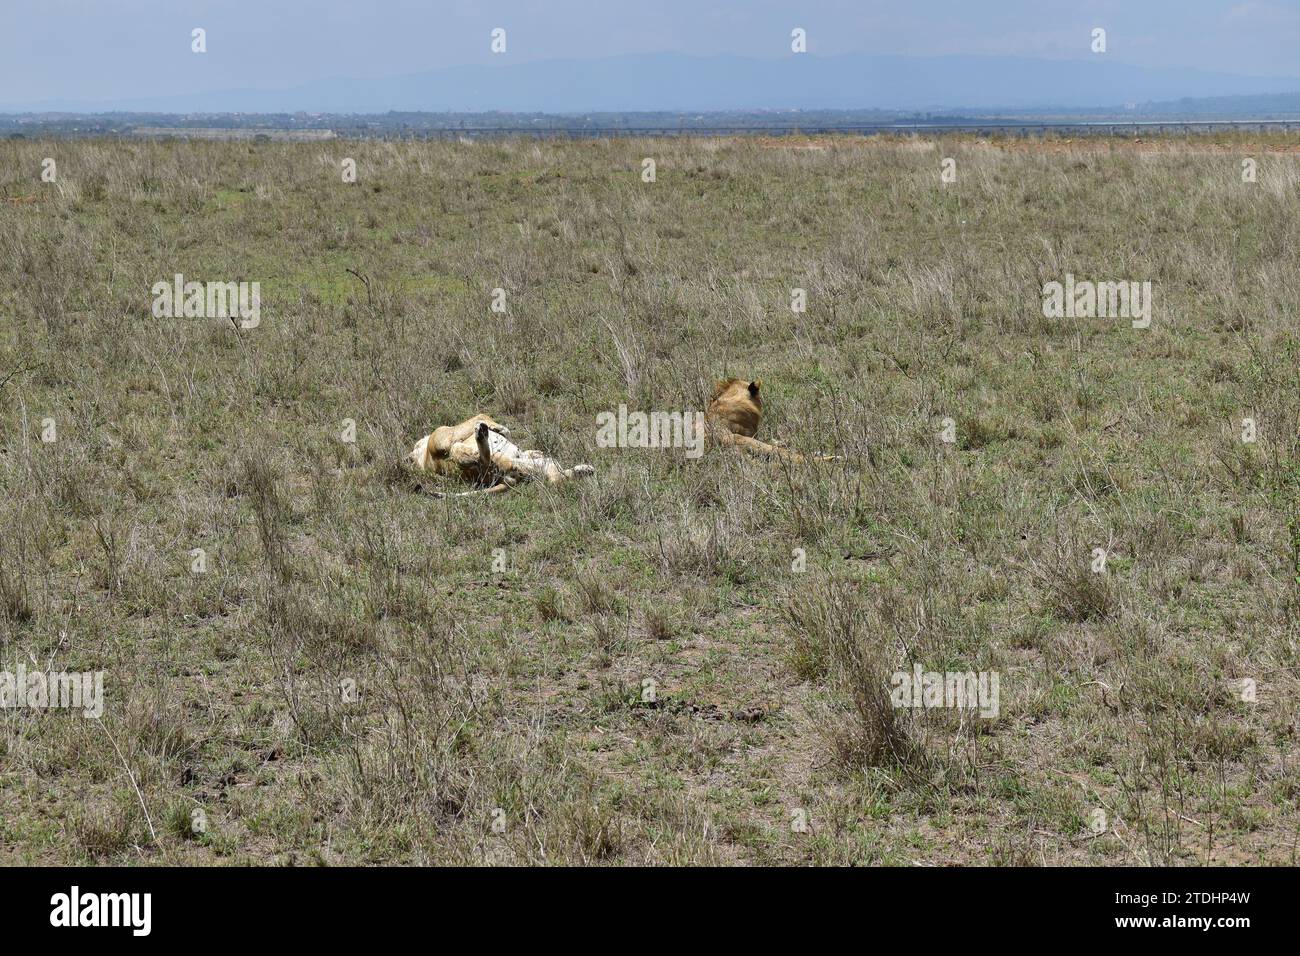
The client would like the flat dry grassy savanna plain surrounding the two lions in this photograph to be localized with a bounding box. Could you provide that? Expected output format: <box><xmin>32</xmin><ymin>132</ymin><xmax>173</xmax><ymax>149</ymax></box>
<box><xmin>0</xmin><ymin>137</ymin><xmax>1300</xmax><ymax>865</ymax></box>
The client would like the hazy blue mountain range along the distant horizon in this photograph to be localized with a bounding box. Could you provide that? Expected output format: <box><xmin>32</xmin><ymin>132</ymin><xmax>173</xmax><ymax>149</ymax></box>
<box><xmin>0</xmin><ymin>53</ymin><xmax>1300</xmax><ymax>113</ymax></box>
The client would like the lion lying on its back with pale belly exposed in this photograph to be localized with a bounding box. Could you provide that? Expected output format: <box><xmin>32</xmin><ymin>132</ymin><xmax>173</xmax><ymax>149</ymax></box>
<box><xmin>406</xmin><ymin>414</ymin><xmax>595</xmax><ymax>498</ymax></box>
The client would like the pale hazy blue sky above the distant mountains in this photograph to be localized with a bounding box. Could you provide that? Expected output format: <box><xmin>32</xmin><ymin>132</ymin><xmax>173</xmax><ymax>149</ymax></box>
<box><xmin>0</xmin><ymin>0</ymin><xmax>1300</xmax><ymax>103</ymax></box>
